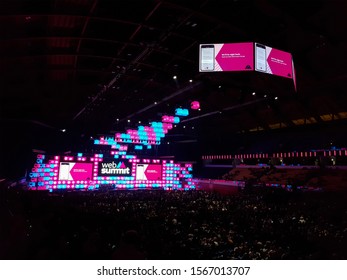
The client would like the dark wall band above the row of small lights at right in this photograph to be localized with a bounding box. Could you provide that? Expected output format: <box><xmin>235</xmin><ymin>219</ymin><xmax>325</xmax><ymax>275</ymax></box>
<box><xmin>200</xmin><ymin>122</ymin><xmax>347</xmax><ymax>155</ymax></box>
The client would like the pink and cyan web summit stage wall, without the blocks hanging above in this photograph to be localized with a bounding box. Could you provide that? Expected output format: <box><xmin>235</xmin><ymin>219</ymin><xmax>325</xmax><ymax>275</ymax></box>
<box><xmin>29</xmin><ymin>154</ymin><xmax>196</xmax><ymax>190</ymax></box>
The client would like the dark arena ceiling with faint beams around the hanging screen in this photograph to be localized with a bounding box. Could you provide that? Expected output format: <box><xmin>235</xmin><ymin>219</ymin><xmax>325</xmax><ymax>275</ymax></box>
<box><xmin>0</xmin><ymin>0</ymin><xmax>347</xmax><ymax>177</ymax></box>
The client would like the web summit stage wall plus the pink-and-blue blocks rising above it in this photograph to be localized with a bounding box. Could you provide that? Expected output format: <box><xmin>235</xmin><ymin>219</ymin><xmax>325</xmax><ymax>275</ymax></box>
<box><xmin>28</xmin><ymin>108</ymin><xmax>195</xmax><ymax>191</ymax></box>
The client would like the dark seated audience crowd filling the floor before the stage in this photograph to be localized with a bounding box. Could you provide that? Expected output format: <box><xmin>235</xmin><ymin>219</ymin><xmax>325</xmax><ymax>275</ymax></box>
<box><xmin>0</xmin><ymin>184</ymin><xmax>347</xmax><ymax>260</ymax></box>
